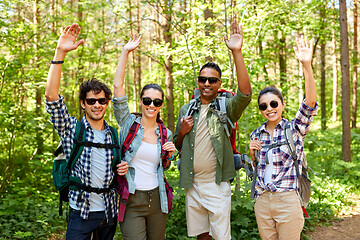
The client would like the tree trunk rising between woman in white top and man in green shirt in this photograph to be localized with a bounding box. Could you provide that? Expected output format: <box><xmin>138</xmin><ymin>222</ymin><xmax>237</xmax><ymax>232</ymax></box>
<box><xmin>163</xmin><ymin>0</ymin><xmax>175</xmax><ymax>132</ymax></box>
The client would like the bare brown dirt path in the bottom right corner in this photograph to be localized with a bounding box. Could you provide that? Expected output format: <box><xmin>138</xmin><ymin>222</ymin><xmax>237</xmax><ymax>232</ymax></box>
<box><xmin>306</xmin><ymin>196</ymin><xmax>360</xmax><ymax>240</ymax></box>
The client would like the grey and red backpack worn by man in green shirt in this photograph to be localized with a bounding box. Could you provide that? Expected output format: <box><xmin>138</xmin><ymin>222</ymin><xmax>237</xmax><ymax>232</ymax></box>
<box><xmin>177</xmin><ymin>89</ymin><xmax>253</xmax><ymax>174</ymax></box>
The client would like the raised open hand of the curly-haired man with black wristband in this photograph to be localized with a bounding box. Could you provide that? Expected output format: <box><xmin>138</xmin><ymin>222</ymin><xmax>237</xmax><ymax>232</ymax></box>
<box><xmin>56</xmin><ymin>23</ymin><xmax>84</xmax><ymax>53</ymax></box>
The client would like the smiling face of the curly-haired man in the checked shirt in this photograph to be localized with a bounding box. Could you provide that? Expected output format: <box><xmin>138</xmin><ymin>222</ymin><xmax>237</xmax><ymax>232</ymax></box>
<box><xmin>80</xmin><ymin>91</ymin><xmax>108</xmax><ymax>124</ymax></box>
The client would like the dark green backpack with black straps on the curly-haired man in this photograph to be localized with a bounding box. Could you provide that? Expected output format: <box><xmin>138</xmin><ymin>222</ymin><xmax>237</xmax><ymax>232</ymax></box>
<box><xmin>52</xmin><ymin>121</ymin><xmax>120</xmax><ymax>216</ymax></box>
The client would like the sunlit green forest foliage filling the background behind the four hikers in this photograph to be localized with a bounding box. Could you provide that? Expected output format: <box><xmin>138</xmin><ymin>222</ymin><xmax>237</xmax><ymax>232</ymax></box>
<box><xmin>0</xmin><ymin>0</ymin><xmax>360</xmax><ymax>239</ymax></box>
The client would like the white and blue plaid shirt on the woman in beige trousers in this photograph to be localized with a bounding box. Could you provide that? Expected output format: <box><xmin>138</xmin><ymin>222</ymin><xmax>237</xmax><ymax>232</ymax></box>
<box><xmin>250</xmin><ymin>101</ymin><xmax>318</xmax><ymax>200</ymax></box>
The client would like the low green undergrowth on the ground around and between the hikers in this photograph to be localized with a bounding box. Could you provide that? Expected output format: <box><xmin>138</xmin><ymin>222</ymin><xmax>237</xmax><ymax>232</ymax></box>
<box><xmin>0</xmin><ymin>127</ymin><xmax>360</xmax><ymax>240</ymax></box>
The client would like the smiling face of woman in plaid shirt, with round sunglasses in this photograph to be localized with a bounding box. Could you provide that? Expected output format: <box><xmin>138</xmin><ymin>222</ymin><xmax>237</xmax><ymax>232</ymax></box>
<box><xmin>259</xmin><ymin>92</ymin><xmax>285</xmax><ymax>124</ymax></box>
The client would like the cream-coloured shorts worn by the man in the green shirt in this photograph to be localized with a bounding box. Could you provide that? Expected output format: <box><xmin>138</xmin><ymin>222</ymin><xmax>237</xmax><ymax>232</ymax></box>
<box><xmin>185</xmin><ymin>182</ymin><xmax>231</xmax><ymax>240</ymax></box>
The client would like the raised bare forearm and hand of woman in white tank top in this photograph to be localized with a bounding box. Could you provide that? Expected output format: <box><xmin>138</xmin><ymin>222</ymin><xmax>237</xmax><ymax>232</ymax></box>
<box><xmin>114</xmin><ymin>34</ymin><xmax>141</xmax><ymax>98</ymax></box>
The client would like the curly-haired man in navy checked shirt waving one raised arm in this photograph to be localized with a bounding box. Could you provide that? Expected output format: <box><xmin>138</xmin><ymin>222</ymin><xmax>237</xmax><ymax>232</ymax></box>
<box><xmin>45</xmin><ymin>24</ymin><xmax>128</xmax><ymax>240</ymax></box>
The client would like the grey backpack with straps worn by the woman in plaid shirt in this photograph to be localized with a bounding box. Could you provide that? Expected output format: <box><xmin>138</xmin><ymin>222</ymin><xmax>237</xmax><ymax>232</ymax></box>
<box><xmin>251</xmin><ymin>121</ymin><xmax>311</xmax><ymax>217</ymax></box>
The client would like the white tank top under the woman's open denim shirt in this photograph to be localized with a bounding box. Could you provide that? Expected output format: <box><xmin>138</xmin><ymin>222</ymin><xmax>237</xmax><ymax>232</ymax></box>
<box><xmin>130</xmin><ymin>141</ymin><xmax>160</xmax><ymax>190</ymax></box>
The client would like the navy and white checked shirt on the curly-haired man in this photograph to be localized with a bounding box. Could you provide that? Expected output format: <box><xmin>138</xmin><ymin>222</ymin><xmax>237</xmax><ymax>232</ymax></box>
<box><xmin>46</xmin><ymin>96</ymin><xmax>117</xmax><ymax>219</ymax></box>
